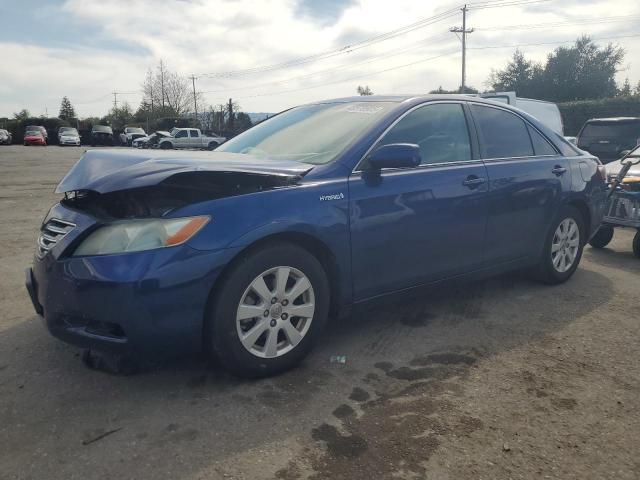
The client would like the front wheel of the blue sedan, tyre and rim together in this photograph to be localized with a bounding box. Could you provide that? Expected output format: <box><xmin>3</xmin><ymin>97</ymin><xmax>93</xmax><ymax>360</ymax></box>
<box><xmin>206</xmin><ymin>243</ymin><xmax>329</xmax><ymax>378</ymax></box>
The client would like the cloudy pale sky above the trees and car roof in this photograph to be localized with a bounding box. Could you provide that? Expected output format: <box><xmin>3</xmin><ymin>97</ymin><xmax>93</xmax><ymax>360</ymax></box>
<box><xmin>0</xmin><ymin>0</ymin><xmax>640</xmax><ymax>117</ymax></box>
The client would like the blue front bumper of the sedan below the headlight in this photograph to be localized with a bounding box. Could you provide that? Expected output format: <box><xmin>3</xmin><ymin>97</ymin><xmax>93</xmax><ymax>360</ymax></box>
<box><xmin>26</xmin><ymin>205</ymin><xmax>240</xmax><ymax>353</ymax></box>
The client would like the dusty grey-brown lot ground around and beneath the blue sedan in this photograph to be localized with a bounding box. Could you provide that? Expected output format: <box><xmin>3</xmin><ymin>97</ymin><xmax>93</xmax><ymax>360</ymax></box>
<box><xmin>0</xmin><ymin>146</ymin><xmax>640</xmax><ymax>480</ymax></box>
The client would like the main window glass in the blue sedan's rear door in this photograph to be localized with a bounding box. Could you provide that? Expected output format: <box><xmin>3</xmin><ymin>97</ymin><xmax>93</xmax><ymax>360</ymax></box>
<box><xmin>471</xmin><ymin>105</ymin><xmax>533</xmax><ymax>158</ymax></box>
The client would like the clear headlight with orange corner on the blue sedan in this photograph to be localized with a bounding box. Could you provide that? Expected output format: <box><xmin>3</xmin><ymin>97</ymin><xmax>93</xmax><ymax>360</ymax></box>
<box><xmin>73</xmin><ymin>216</ymin><xmax>210</xmax><ymax>256</ymax></box>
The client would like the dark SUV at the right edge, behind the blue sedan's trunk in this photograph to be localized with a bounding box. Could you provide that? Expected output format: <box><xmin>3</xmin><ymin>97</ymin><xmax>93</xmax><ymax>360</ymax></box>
<box><xmin>577</xmin><ymin>117</ymin><xmax>640</xmax><ymax>164</ymax></box>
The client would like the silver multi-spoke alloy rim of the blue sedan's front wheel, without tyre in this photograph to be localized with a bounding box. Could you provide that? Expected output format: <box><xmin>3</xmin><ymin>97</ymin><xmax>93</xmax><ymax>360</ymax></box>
<box><xmin>236</xmin><ymin>266</ymin><xmax>315</xmax><ymax>358</ymax></box>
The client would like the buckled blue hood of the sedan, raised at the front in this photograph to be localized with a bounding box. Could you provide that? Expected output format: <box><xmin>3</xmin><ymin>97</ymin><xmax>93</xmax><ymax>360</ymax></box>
<box><xmin>56</xmin><ymin>150</ymin><xmax>313</xmax><ymax>193</ymax></box>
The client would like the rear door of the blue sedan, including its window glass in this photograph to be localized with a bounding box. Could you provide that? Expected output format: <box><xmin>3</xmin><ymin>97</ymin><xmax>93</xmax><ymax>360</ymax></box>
<box><xmin>470</xmin><ymin>104</ymin><xmax>571</xmax><ymax>265</ymax></box>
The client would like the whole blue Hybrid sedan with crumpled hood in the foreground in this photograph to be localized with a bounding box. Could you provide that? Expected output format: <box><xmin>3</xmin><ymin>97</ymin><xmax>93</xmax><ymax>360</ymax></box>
<box><xmin>27</xmin><ymin>95</ymin><xmax>606</xmax><ymax>377</ymax></box>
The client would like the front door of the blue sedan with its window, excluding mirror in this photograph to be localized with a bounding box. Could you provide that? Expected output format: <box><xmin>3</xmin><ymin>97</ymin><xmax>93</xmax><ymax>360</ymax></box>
<box><xmin>349</xmin><ymin>102</ymin><xmax>487</xmax><ymax>300</ymax></box>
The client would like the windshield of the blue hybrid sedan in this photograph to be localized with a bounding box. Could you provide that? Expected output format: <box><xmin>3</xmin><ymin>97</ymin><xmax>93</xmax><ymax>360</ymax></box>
<box><xmin>216</xmin><ymin>102</ymin><xmax>397</xmax><ymax>165</ymax></box>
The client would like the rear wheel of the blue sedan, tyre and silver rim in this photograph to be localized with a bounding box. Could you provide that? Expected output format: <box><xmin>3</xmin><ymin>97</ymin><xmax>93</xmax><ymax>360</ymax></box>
<box><xmin>534</xmin><ymin>205</ymin><xmax>584</xmax><ymax>285</ymax></box>
